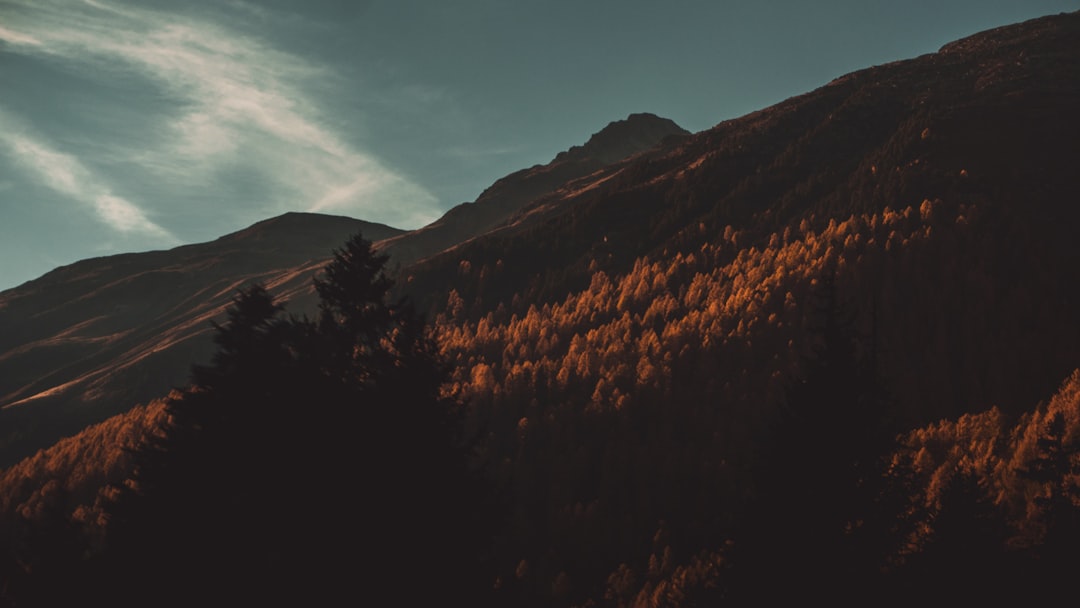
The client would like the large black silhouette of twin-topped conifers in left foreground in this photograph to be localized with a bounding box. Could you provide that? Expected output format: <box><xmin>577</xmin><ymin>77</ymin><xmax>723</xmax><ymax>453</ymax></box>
<box><xmin>90</xmin><ymin>234</ymin><xmax>496</xmax><ymax>606</ymax></box>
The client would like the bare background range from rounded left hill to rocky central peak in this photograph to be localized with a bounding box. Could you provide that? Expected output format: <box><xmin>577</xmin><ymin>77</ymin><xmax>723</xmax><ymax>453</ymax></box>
<box><xmin>0</xmin><ymin>113</ymin><xmax>687</xmax><ymax>465</ymax></box>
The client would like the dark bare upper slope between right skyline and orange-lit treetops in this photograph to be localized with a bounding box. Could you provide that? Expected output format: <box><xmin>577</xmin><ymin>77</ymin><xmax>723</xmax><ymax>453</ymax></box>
<box><xmin>407</xmin><ymin>8</ymin><xmax>1080</xmax><ymax>332</ymax></box>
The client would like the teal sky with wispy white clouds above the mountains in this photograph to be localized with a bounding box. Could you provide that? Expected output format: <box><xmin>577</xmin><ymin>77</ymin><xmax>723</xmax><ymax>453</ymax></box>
<box><xmin>0</xmin><ymin>0</ymin><xmax>1080</xmax><ymax>291</ymax></box>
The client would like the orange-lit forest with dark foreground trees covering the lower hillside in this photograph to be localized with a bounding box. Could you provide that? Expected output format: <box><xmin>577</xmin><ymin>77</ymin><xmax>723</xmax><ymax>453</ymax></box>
<box><xmin>2</xmin><ymin>207</ymin><xmax>1080</xmax><ymax>606</ymax></box>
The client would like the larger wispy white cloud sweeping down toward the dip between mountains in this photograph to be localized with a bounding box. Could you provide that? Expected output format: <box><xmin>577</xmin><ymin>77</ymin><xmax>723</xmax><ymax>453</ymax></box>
<box><xmin>0</xmin><ymin>0</ymin><xmax>437</xmax><ymax>228</ymax></box>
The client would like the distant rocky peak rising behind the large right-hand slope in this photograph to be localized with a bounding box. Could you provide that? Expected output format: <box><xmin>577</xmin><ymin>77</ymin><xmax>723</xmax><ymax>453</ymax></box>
<box><xmin>379</xmin><ymin>113</ymin><xmax>689</xmax><ymax>266</ymax></box>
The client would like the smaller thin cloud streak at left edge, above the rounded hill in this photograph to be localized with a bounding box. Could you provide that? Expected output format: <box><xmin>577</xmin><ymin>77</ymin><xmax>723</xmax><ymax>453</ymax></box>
<box><xmin>0</xmin><ymin>111</ymin><xmax>178</xmax><ymax>240</ymax></box>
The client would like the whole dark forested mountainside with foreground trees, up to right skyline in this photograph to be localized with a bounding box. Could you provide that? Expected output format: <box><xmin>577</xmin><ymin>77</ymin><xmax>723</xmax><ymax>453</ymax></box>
<box><xmin>0</xmin><ymin>13</ymin><xmax>1080</xmax><ymax>608</ymax></box>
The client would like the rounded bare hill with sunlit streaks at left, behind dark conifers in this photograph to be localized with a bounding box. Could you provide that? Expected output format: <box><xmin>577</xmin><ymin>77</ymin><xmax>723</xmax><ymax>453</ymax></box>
<box><xmin>0</xmin><ymin>213</ymin><xmax>402</xmax><ymax>463</ymax></box>
